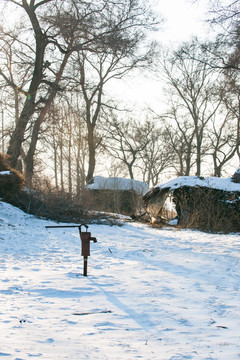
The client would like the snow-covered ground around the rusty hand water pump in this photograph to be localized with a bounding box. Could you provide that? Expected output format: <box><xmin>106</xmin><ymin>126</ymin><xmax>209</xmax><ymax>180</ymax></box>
<box><xmin>0</xmin><ymin>202</ymin><xmax>240</xmax><ymax>360</ymax></box>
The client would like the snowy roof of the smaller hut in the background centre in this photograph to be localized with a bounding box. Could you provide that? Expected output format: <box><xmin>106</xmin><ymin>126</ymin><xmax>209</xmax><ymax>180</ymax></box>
<box><xmin>87</xmin><ymin>176</ymin><xmax>148</xmax><ymax>194</ymax></box>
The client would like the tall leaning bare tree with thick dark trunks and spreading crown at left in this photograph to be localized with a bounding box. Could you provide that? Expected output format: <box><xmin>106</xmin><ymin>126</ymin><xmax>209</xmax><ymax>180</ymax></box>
<box><xmin>0</xmin><ymin>0</ymin><xmax>161</xmax><ymax>184</ymax></box>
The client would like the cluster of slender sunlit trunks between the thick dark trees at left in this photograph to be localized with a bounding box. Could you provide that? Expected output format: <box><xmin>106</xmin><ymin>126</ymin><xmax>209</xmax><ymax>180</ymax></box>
<box><xmin>39</xmin><ymin>97</ymin><xmax>87</xmax><ymax>196</ymax></box>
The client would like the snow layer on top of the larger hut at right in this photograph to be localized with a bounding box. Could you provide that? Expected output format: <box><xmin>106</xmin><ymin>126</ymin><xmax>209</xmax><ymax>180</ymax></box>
<box><xmin>155</xmin><ymin>176</ymin><xmax>240</xmax><ymax>191</ymax></box>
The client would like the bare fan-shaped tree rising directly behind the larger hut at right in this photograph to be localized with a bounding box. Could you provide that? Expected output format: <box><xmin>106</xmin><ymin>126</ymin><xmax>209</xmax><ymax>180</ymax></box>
<box><xmin>160</xmin><ymin>44</ymin><xmax>221</xmax><ymax>175</ymax></box>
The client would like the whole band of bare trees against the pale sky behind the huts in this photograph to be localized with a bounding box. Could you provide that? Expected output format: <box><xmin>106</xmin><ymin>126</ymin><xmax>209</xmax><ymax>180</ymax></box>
<box><xmin>0</xmin><ymin>0</ymin><xmax>240</xmax><ymax>194</ymax></box>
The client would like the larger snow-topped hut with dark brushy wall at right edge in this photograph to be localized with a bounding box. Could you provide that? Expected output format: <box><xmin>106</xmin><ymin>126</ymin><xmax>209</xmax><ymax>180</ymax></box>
<box><xmin>143</xmin><ymin>170</ymin><xmax>240</xmax><ymax>232</ymax></box>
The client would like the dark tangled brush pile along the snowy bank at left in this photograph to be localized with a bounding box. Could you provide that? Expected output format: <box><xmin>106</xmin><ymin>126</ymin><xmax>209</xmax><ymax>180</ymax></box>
<box><xmin>0</xmin><ymin>153</ymin><xmax>124</xmax><ymax>225</ymax></box>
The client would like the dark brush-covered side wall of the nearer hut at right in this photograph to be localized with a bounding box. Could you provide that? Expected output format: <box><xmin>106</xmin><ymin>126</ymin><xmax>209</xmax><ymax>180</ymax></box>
<box><xmin>173</xmin><ymin>186</ymin><xmax>240</xmax><ymax>233</ymax></box>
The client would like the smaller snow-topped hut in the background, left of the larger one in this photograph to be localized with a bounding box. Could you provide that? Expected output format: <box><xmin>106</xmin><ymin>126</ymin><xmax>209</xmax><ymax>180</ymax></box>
<box><xmin>86</xmin><ymin>176</ymin><xmax>148</xmax><ymax>216</ymax></box>
